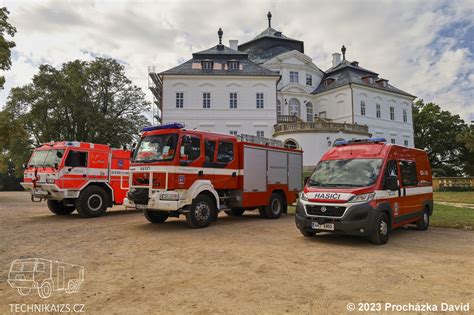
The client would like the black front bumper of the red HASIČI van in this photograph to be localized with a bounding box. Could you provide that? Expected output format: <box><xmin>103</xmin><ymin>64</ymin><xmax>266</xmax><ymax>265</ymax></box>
<box><xmin>295</xmin><ymin>201</ymin><xmax>376</xmax><ymax>236</ymax></box>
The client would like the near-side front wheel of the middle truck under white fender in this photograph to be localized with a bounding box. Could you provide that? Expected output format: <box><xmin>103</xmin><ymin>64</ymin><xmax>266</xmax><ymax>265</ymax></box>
<box><xmin>186</xmin><ymin>195</ymin><xmax>216</xmax><ymax>229</ymax></box>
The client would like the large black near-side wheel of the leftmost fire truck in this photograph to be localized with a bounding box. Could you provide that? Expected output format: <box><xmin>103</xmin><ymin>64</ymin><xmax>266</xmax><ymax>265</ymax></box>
<box><xmin>76</xmin><ymin>186</ymin><xmax>109</xmax><ymax>218</ymax></box>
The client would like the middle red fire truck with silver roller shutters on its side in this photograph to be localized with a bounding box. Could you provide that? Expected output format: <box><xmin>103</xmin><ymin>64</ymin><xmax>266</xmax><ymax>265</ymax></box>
<box><xmin>124</xmin><ymin>123</ymin><xmax>302</xmax><ymax>228</ymax></box>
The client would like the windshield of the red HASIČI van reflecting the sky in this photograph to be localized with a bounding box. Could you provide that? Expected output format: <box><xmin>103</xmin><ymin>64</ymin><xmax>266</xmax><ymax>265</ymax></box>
<box><xmin>308</xmin><ymin>159</ymin><xmax>383</xmax><ymax>187</ymax></box>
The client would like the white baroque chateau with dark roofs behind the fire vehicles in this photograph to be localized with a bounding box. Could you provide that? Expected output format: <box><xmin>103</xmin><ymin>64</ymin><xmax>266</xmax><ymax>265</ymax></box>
<box><xmin>150</xmin><ymin>12</ymin><xmax>415</xmax><ymax>168</ymax></box>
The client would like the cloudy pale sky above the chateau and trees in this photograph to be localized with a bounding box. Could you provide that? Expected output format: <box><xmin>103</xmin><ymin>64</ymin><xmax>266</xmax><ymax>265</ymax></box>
<box><xmin>0</xmin><ymin>0</ymin><xmax>474</xmax><ymax>120</ymax></box>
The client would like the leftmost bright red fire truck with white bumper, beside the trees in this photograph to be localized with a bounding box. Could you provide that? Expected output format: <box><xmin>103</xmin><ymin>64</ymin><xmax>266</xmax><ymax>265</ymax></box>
<box><xmin>21</xmin><ymin>141</ymin><xmax>130</xmax><ymax>217</ymax></box>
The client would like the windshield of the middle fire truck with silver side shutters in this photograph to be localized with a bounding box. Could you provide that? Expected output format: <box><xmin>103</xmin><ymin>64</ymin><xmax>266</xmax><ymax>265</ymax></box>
<box><xmin>133</xmin><ymin>133</ymin><xmax>178</xmax><ymax>163</ymax></box>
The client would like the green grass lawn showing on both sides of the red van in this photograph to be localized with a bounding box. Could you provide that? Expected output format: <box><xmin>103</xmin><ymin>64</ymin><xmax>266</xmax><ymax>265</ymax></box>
<box><xmin>288</xmin><ymin>203</ymin><xmax>474</xmax><ymax>230</ymax></box>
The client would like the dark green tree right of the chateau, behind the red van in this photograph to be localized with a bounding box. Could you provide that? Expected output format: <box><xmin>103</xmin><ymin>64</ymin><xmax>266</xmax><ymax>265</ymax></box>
<box><xmin>413</xmin><ymin>100</ymin><xmax>468</xmax><ymax>176</ymax></box>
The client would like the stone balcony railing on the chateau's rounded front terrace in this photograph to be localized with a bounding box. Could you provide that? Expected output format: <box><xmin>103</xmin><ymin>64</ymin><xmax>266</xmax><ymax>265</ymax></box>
<box><xmin>273</xmin><ymin>116</ymin><xmax>370</xmax><ymax>136</ymax></box>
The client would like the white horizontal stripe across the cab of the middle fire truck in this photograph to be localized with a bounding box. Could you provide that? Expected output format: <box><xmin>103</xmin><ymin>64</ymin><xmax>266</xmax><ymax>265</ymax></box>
<box><xmin>130</xmin><ymin>165</ymin><xmax>244</xmax><ymax>175</ymax></box>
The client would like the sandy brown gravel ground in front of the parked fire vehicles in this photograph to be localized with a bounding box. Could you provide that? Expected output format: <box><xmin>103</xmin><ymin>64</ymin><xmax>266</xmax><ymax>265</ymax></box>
<box><xmin>0</xmin><ymin>192</ymin><xmax>474</xmax><ymax>314</ymax></box>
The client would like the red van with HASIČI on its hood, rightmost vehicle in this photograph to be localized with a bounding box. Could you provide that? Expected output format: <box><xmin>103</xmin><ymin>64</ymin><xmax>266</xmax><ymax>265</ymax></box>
<box><xmin>295</xmin><ymin>138</ymin><xmax>433</xmax><ymax>244</ymax></box>
